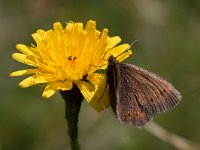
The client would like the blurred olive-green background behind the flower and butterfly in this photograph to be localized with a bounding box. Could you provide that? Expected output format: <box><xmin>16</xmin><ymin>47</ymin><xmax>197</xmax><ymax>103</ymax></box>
<box><xmin>0</xmin><ymin>0</ymin><xmax>200</xmax><ymax>150</ymax></box>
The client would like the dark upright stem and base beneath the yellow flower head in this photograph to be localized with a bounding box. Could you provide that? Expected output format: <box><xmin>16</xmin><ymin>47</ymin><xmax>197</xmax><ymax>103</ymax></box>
<box><xmin>60</xmin><ymin>86</ymin><xmax>83</xmax><ymax>150</ymax></box>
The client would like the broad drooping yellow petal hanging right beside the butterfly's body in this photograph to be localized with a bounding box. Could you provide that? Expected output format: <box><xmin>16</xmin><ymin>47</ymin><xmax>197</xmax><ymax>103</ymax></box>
<box><xmin>77</xmin><ymin>73</ymin><xmax>110</xmax><ymax>112</ymax></box>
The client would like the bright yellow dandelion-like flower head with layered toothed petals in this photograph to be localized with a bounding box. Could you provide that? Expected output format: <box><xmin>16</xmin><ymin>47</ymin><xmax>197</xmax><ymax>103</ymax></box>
<box><xmin>10</xmin><ymin>20</ymin><xmax>131</xmax><ymax>111</ymax></box>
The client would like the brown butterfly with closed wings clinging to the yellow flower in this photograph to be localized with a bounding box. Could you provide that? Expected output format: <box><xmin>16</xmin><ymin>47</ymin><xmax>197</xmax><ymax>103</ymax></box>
<box><xmin>107</xmin><ymin>56</ymin><xmax>181</xmax><ymax>127</ymax></box>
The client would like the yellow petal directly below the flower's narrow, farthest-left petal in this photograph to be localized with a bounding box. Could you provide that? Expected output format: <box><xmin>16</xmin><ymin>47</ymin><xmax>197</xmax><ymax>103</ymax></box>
<box><xmin>19</xmin><ymin>75</ymin><xmax>48</xmax><ymax>88</ymax></box>
